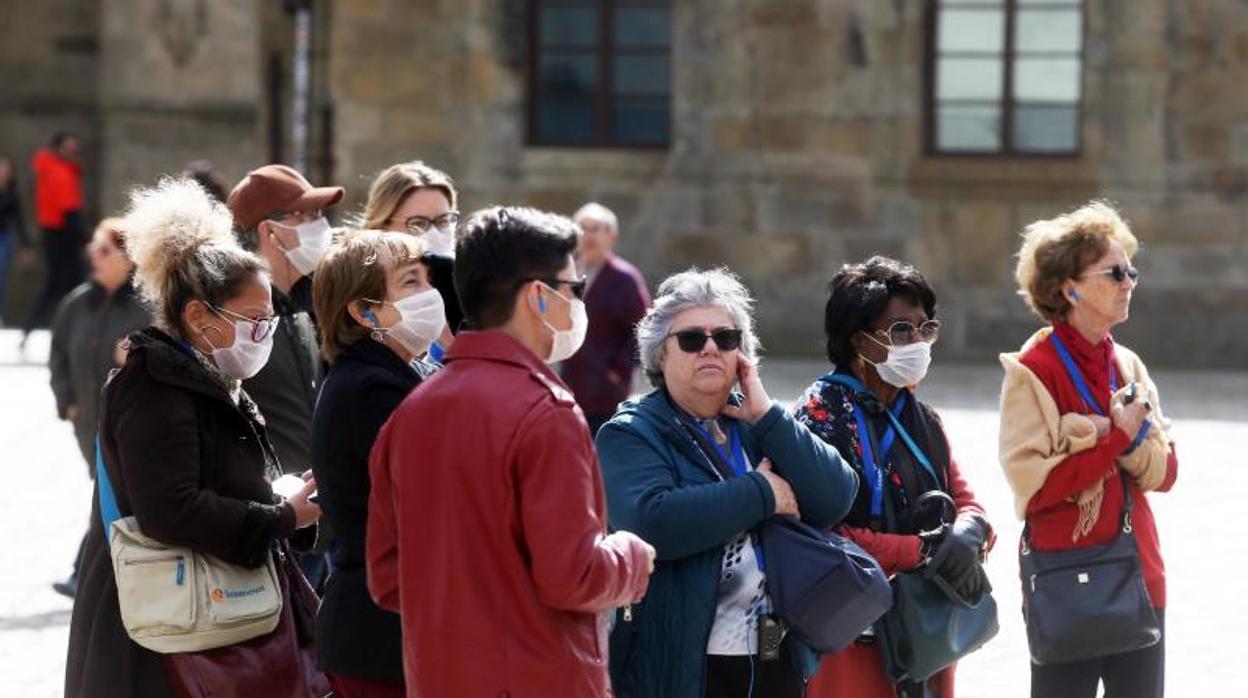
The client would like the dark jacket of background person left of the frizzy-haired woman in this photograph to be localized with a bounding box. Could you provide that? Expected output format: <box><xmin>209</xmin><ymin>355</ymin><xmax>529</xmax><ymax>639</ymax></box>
<box><xmin>47</xmin><ymin>281</ymin><xmax>151</xmax><ymax>477</ymax></box>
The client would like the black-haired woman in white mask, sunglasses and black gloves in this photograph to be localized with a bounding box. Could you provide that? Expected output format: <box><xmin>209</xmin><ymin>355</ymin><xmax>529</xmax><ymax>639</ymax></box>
<box><xmin>795</xmin><ymin>257</ymin><xmax>993</xmax><ymax>698</ymax></box>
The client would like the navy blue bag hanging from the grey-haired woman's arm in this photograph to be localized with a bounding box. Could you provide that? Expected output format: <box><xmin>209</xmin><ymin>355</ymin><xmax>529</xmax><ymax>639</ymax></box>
<box><xmin>759</xmin><ymin>516</ymin><xmax>892</xmax><ymax>653</ymax></box>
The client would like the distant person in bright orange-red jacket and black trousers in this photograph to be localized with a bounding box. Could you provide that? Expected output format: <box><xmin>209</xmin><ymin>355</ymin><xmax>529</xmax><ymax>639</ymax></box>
<box><xmin>19</xmin><ymin>131</ymin><xmax>86</xmax><ymax>347</ymax></box>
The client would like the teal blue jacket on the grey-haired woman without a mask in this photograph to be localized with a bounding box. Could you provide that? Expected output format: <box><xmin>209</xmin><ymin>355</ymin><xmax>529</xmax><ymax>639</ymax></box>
<box><xmin>597</xmin><ymin>388</ymin><xmax>857</xmax><ymax>698</ymax></box>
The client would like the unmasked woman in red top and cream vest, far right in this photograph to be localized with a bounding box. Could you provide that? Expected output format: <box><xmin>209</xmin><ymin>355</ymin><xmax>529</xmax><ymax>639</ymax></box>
<box><xmin>1001</xmin><ymin>201</ymin><xmax>1178</xmax><ymax>698</ymax></box>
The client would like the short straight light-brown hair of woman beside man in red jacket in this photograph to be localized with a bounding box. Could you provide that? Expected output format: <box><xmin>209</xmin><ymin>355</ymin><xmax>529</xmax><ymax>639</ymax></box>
<box><xmin>312</xmin><ymin>230</ymin><xmax>424</xmax><ymax>362</ymax></box>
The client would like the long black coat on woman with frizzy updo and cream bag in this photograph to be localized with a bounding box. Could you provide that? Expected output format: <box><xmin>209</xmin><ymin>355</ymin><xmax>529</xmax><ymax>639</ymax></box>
<box><xmin>65</xmin><ymin>328</ymin><xmax>307</xmax><ymax>698</ymax></box>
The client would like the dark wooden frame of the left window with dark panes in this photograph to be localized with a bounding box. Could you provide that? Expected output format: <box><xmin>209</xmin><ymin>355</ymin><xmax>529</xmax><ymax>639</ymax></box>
<box><xmin>525</xmin><ymin>0</ymin><xmax>675</xmax><ymax>150</ymax></box>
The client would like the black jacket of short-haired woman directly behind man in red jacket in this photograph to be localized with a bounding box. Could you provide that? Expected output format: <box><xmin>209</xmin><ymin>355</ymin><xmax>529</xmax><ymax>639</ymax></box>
<box><xmin>312</xmin><ymin>340</ymin><xmax>428</xmax><ymax>683</ymax></box>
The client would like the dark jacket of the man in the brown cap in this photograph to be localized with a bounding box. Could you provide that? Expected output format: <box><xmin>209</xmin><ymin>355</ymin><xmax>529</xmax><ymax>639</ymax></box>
<box><xmin>242</xmin><ymin>276</ymin><xmax>322</xmax><ymax>473</ymax></box>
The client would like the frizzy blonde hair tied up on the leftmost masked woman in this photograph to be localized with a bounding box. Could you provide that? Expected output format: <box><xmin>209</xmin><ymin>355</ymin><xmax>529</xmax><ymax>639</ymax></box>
<box><xmin>121</xmin><ymin>177</ymin><xmax>266</xmax><ymax>336</ymax></box>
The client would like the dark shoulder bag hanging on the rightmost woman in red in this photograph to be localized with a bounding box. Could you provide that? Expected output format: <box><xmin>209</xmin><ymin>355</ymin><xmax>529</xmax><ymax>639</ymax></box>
<box><xmin>1018</xmin><ymin>471</ymin><xmax>1162</xmax><ymax>664</ymax></box>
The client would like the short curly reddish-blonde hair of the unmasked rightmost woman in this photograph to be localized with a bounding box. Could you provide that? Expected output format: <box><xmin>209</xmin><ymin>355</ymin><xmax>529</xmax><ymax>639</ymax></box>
<box><xmin>1015</xmin><ymin>201</ymin><xmax>1139</xmax><ymax>322</ymax></box>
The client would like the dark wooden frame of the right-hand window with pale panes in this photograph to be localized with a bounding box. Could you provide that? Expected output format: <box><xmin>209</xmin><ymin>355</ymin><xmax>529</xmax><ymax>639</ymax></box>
<box><xmin>921</xmin><ymin>0</ymin><xmax>1087</xmax><ymax>160</ymax></box>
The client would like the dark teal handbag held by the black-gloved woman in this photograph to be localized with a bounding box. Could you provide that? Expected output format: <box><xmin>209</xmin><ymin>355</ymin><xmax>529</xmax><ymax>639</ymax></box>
<box><xmin>875</xmin><ymin>491</ymin><xmax>1000</xmax><ymax>683</ymax></box>
